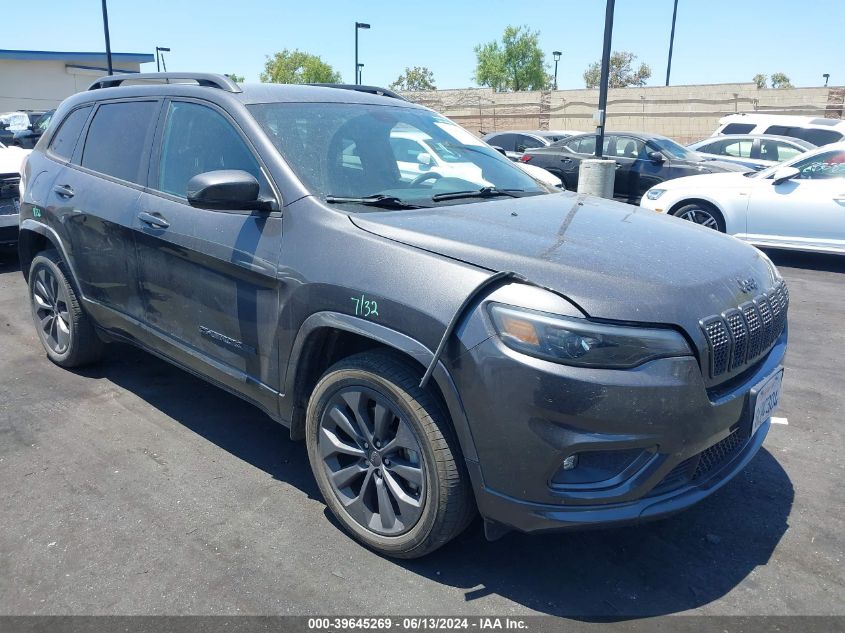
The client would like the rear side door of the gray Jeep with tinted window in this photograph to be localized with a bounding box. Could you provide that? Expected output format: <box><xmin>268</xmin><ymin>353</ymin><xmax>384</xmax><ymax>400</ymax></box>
<box><xmin>47</xmin><ymin>99</ymin><xmax>161</xmax><ymax>327</ymax></box>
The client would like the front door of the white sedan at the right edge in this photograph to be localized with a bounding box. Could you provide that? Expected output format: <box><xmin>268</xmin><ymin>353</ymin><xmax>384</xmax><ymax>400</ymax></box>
<box><xmin>748</xmin><ymin>150</ymin><xmax>845</xmax><ymax>251</ymax></box>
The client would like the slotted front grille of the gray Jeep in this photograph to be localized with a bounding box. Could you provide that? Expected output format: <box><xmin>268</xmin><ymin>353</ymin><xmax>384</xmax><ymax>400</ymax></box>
<box><xmin>701</xmin><ymin>281</ymin><xmax>789</xmax><ymax>378</ymax></box>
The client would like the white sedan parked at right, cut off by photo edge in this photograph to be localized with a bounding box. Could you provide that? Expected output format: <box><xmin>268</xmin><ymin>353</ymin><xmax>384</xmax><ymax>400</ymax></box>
<box><xmin>640</xmin><ymin>142</ymin><xmax>845</xmax><ymax>254</ymax></box>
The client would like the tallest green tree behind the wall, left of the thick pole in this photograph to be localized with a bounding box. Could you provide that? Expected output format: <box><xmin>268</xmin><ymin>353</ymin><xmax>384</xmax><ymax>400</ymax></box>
<box><xmin>475</xmin><ymin>26</ymin><xmax>552</xmax><ymax>91</ymax></box>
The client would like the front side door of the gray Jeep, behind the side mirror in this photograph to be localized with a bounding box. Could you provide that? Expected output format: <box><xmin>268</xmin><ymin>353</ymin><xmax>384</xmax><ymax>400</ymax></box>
<box><xmin>135</xmin><ymin>99</ymin><xmax>282</xmax><ymax>410</ymax></box>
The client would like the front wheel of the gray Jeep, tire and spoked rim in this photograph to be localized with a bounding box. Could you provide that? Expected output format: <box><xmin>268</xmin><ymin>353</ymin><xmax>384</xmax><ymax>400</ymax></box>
<box><xmin>306</xmin><ymin>352</ymin><xmax>475</xmax><ymax>558</ymax></box>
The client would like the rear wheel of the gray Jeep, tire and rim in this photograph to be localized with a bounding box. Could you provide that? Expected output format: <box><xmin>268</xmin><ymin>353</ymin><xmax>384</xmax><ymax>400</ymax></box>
<box><xmin>27</xmin><ymin>250</ymin><xmax>103</xmax><ymax>368</ymax></box>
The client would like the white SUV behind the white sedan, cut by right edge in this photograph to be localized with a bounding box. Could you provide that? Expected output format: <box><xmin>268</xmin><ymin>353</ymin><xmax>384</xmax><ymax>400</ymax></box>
<box><xmin>713</xmin><ymin>112</ymin><xmax>845</xmax><ymax>147</ymax></box>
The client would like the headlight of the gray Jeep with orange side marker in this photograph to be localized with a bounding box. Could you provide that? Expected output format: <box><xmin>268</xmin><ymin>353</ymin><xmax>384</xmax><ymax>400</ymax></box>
<box><xmin>489</xmin><ymin>304</ymin><xmax>692</xmax><ymax>369</ymax></box>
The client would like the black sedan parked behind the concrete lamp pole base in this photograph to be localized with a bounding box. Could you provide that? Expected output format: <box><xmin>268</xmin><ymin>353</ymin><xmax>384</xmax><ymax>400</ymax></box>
<box><xmin>520</xmin><ymin>132</ymin><xmax>749</xmax><ymax>204</ymax></box>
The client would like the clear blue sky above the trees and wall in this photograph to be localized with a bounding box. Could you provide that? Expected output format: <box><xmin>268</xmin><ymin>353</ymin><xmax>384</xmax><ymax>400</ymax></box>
<box><xmin>6</xmin><ymin>0</ymin><xmax>845</xmax><ymax>89</ymax></box>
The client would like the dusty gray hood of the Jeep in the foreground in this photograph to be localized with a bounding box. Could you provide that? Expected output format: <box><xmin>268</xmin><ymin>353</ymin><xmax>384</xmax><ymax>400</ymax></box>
<box><xmin>350</xmin><ymin>193</ymin><xmax>775</xmax><ymax>333</ymax></box>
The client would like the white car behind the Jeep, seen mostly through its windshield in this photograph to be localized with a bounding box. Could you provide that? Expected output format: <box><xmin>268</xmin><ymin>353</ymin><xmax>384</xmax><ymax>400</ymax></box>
<box><xmin>390</xmin><ymin>127</ymin><xmax>561</xmax><ymax>188</ymax></box>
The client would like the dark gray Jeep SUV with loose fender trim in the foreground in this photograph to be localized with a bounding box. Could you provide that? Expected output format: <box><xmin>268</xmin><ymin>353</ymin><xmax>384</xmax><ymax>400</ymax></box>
<box><xmin>19</xmin><ymin>73</ymin><xmax>787</xmax><ymax>558</ymax></box>
